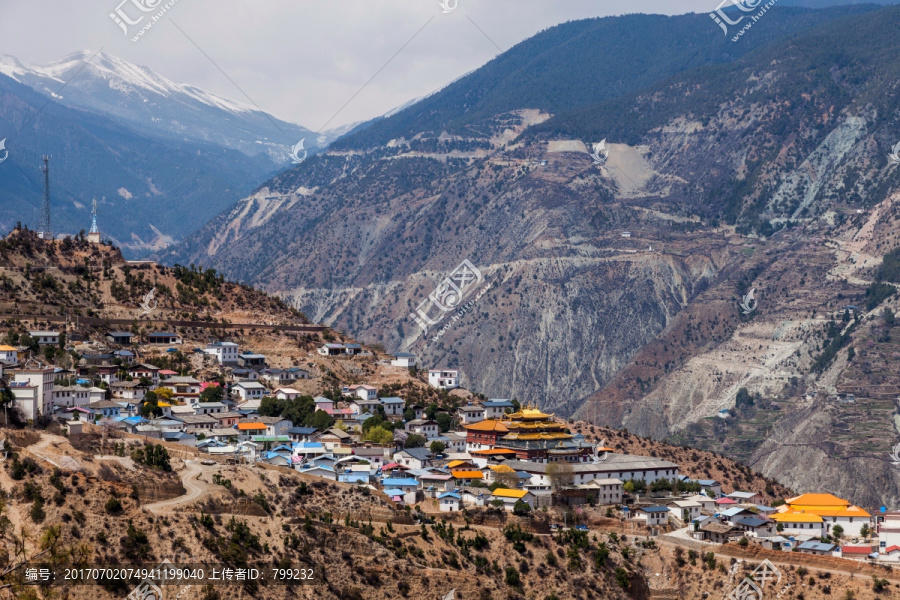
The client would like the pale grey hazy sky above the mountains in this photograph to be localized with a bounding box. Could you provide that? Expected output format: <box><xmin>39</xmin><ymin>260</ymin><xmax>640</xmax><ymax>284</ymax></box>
<box><xmin>0</xmin><ymin>0</ymin><xmax>718</xmax><ymax>131</ymax></box>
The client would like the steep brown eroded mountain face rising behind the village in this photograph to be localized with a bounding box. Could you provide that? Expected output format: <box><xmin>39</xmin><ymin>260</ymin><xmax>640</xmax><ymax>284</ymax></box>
<box><xmin>164</xmin><ymin>7</ymin><xmax>900</xmax><ymax>502</ymax></box>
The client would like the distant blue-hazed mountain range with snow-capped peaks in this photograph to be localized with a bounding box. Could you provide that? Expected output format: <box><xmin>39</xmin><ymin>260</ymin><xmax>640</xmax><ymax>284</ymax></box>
<box><xmin>0</xmin><ymin>51</ymin><xmax>355</xmax><ymax>257</ymax></box>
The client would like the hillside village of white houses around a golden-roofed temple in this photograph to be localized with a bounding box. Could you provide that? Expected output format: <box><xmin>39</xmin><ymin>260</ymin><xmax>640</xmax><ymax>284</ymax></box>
<box><xmin>0</xmin><ymin>328</ymin><xmax>900</xmax><ymax>564</ymax></box>
